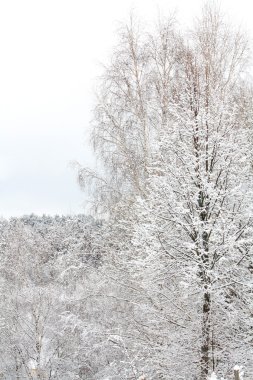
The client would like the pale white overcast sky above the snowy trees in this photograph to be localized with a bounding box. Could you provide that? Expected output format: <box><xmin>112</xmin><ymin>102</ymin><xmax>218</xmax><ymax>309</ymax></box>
<box><xmin>0</xmin><ymin>0</ymin><xmax>253</xmax><ymax>217</ymax></box>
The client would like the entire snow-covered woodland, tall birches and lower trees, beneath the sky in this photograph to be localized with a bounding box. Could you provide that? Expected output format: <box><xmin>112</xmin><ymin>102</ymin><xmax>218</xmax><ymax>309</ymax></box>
<box><xmin>0</xmin><ymin>3</ymin><xmax>253</xmax><ymax>380</ymax></box>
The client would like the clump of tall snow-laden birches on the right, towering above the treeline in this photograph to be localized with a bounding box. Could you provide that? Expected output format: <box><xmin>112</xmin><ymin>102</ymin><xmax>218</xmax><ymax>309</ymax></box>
<box><xmin>80</xmin><ymin>5</ymin><xmax>252</xmax><ymax>379</ymax></box>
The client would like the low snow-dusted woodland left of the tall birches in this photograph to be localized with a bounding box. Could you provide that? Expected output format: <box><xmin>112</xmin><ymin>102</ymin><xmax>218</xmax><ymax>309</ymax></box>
<box><xmin>0</xmin><ymin>215</ymin><xmax>107</xmax><ymax>380</ymax></box>
